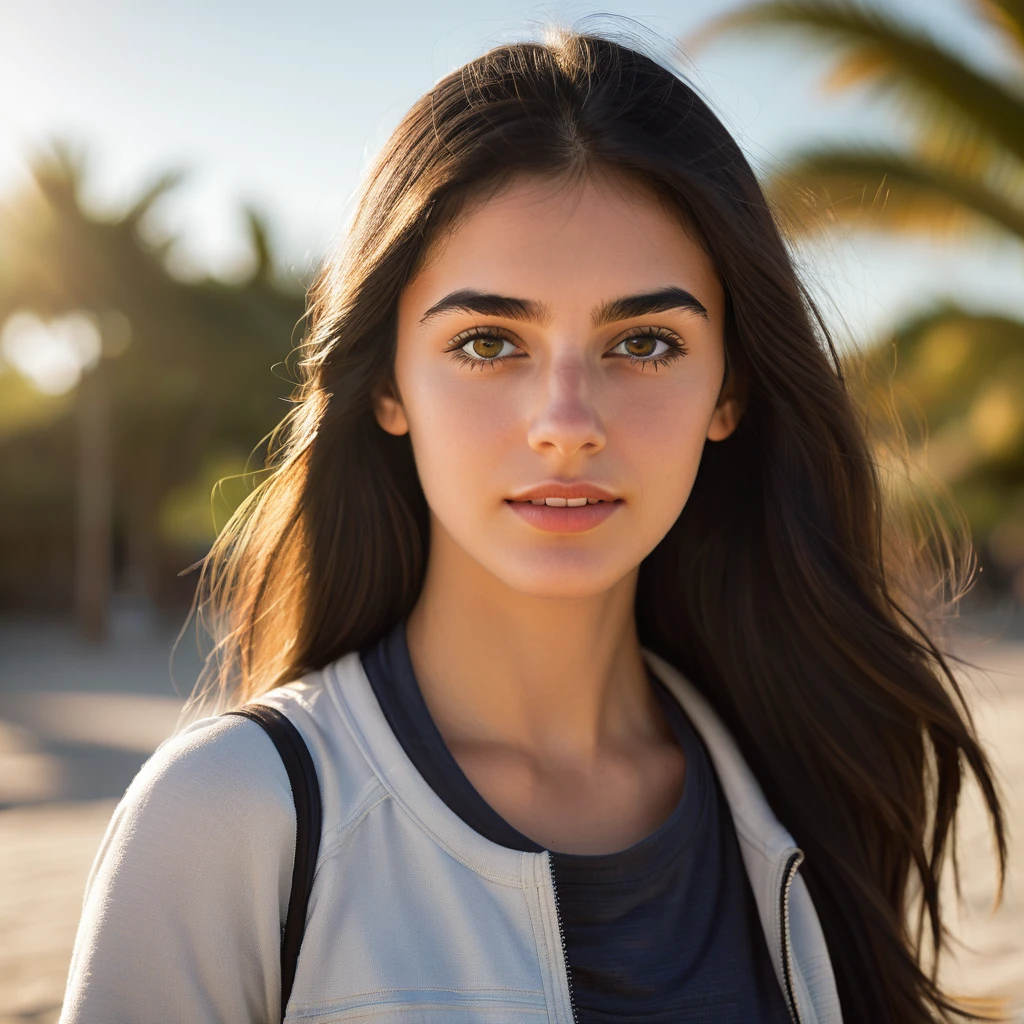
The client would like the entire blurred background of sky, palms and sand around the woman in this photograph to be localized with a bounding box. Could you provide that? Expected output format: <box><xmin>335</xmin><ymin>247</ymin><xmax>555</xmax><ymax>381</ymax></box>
<box><xmin>0</xmin><ymin>0</ymin><xmax>1024</xmax><ymax>1024</ymax></box>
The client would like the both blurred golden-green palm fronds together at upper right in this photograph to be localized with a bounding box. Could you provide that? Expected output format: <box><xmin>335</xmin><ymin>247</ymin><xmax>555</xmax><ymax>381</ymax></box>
<box><xmin>690</xmin><ymin>0</ymin><xmax>1024</xmax><ymax>241</ymax></box>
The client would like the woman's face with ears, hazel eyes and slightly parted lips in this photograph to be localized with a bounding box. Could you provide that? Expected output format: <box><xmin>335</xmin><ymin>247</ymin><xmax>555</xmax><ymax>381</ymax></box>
<box><xmin>376</xmin><ymin>168</ymin><xmax>738</xmax><ymax>598</ymax></box>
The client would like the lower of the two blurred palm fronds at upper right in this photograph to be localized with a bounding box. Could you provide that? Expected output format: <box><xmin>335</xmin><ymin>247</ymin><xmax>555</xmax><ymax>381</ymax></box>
<box><xmin>767</xmin><ymin>147</ymin><xmax>1024</xmax><ymax>242</ymax></box>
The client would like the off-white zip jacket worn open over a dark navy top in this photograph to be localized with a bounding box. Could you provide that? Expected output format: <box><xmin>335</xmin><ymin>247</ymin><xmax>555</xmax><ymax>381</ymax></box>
<box><xmin>60</xmin><ymin>651</ymin><xmax>842</xmax><ymax>1024</ymax></box>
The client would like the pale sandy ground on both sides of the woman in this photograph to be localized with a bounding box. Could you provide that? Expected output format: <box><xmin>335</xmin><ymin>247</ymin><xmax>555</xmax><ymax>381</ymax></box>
<box><xmin>0</xmin><ymin>610</ymin><xmax>1024</xmax><ymax>1024</ymax></box>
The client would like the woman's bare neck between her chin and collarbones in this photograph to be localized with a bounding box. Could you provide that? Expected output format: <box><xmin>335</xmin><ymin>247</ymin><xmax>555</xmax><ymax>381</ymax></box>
<box><xmin>408</xmin><ymin>520</ymin><xmax>666</xmax><ymax>765</ymax></box>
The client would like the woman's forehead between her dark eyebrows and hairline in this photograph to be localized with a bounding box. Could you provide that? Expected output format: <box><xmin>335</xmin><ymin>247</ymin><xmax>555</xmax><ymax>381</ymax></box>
<box><xmin>399</xmin><ymin>173</ymin><xmax>723</xmax><ymax>318</ymax></box>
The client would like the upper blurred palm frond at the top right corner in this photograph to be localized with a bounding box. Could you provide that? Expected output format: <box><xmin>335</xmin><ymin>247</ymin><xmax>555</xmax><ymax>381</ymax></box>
<box><xmin>686</xmin><ymin>0</ymin><xmax>1024</xmax><ymax>161</ymax></box>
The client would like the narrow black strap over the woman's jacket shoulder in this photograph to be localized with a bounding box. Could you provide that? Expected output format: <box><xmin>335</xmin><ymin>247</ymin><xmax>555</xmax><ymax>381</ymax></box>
<box><xmin>224</xmin><ymin>703</ymin><xmax>323</xmax><ymax>1021</ymax></box>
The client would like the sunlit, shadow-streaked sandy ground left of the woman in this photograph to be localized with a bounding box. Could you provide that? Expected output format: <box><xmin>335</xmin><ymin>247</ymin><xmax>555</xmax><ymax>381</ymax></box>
<box><xmin>0</xmin><ymin>609</ymin><xmax>199</xmax><ymax>1024</ymax></box>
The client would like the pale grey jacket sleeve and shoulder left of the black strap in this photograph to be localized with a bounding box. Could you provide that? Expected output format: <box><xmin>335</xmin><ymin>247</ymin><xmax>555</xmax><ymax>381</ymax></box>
<box><xmin>61</xmin><ymin>704</ymin><xmax>295</xmax><ymax>1024</ymax></box>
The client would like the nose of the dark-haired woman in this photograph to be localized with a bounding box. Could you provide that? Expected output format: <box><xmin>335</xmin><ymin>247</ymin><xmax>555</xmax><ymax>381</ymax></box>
<box><xmin>527</xmin><ymin>359</ymin><xmax>607</xmax><ymax>457</ymax></box>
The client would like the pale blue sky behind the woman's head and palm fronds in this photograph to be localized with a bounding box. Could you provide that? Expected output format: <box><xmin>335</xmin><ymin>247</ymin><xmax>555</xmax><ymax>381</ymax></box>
<box><xmin>0</xmin><ymin>0</ymin><xmax>1024</xmax><ymax>348</ymax></box>
